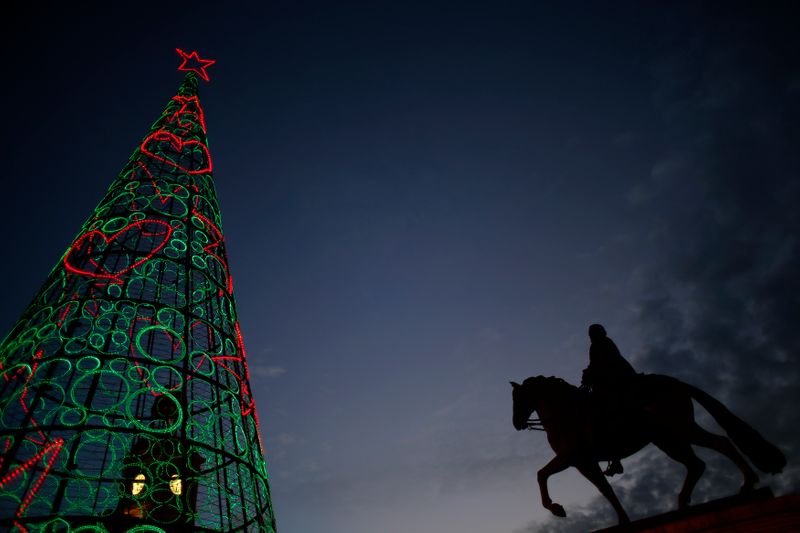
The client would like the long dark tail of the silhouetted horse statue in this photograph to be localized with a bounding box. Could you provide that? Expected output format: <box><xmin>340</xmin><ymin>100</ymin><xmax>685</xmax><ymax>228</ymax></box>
<box><xmin>682</xmin><ymin>383</ymin><xmax>786</xmax><ymax>474</ymax></box>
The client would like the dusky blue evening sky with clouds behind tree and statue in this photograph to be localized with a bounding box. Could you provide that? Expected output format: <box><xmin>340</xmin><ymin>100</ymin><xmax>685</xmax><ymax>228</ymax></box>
<box><xmin>0</xmin><ymin>0</ymin><xmax>800</xmax><ymax>533</ymax></box>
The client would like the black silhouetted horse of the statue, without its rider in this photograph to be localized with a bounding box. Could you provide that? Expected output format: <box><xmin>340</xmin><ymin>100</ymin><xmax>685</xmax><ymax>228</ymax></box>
<box><xmin>511</xmin><ymin>374</ymin><xmax>786</xmax><ymax>524</ymax></box>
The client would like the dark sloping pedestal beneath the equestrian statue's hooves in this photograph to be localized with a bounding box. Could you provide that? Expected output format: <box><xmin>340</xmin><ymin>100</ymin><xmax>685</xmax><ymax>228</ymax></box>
<box><xmin>594</xmin><ymin>489</ymin><xmax>800</xmax><ymax>533</ymax></box>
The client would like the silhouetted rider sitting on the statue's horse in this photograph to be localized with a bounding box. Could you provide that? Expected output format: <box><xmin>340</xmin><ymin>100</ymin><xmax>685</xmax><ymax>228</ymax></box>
<box><xmin>581</xmin><ymin>324</ymin><xmax>636</xmax><ymax>476</ymax></box>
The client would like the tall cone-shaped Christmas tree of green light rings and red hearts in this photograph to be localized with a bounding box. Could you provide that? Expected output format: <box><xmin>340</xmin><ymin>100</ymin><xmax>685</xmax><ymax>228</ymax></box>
<box><xmin>0</xmin><ymin>50</ymin><xmax>275</xmax><ymax>533</ymax></box>
